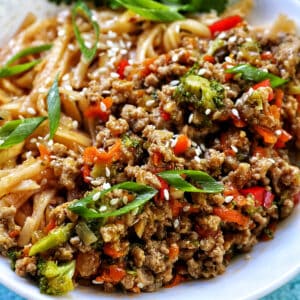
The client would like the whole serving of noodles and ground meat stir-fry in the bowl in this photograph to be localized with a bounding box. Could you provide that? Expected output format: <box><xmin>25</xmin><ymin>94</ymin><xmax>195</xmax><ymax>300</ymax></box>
<box><xmin>0</xmin><ymin>2</ymin><xmax>300</xmax><ymax>295</ymax></box>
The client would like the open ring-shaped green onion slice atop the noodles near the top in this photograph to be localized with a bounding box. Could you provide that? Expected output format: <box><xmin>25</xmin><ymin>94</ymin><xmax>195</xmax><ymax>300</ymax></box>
<box><xmin>72</xmin><ymin>1</ymin><xmax>100</xmax><ymax>62</ymax></box>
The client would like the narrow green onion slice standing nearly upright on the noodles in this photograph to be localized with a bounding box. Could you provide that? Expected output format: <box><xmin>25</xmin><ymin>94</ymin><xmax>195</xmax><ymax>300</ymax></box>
<box><xmin>47</xmin><ymin>75</ymin><xmax>60</xmax><ymax>139</ymax></box>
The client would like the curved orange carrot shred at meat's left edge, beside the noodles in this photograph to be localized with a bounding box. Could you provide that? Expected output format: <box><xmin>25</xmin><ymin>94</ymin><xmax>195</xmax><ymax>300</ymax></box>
<box><xmin>83</xmin><ymin>139</ymin><xmax>122</xmax><ymax>164</ymax></box>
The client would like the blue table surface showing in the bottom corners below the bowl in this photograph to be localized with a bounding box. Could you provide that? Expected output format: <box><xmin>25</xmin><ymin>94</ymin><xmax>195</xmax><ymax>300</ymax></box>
<box><xmin>0</xmin><ymin>275</ymin><xmax>300</xmax><ymax>300</ymax></box>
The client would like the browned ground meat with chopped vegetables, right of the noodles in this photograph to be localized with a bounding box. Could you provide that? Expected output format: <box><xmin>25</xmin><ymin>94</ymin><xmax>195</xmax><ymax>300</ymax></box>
<box><xmin>0</xmin><ymin>0</ymin><xmax>300</xmax><ymax>295</ymax></box>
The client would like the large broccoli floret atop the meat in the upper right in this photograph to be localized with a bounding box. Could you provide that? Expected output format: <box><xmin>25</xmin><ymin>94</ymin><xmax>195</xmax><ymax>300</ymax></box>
<box><xmin>174</xmin><ymin>72</ymin><xmax>224</xmax><ymax>110</ymax></box>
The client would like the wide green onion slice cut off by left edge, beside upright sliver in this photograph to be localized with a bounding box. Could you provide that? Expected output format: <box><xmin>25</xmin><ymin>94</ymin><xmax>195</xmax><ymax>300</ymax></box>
<box><xmin>0</xmin><ymin>117</ymin><xmax>47</xmax><ymax>149</ymax></box>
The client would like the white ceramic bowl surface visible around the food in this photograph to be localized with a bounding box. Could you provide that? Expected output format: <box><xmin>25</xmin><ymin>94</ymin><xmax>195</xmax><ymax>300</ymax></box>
<box><xmin>0</xmin><ymin>0</ymin><xmax>300</xmax><ymax>300</ymax></box>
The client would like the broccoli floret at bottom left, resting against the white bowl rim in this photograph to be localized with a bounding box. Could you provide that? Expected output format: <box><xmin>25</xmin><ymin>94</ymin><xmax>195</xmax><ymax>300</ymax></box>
<box><xmin>37</xmin><ymin>260</ymin><xmax>75</xmax><ymax>296</ymax></box>
